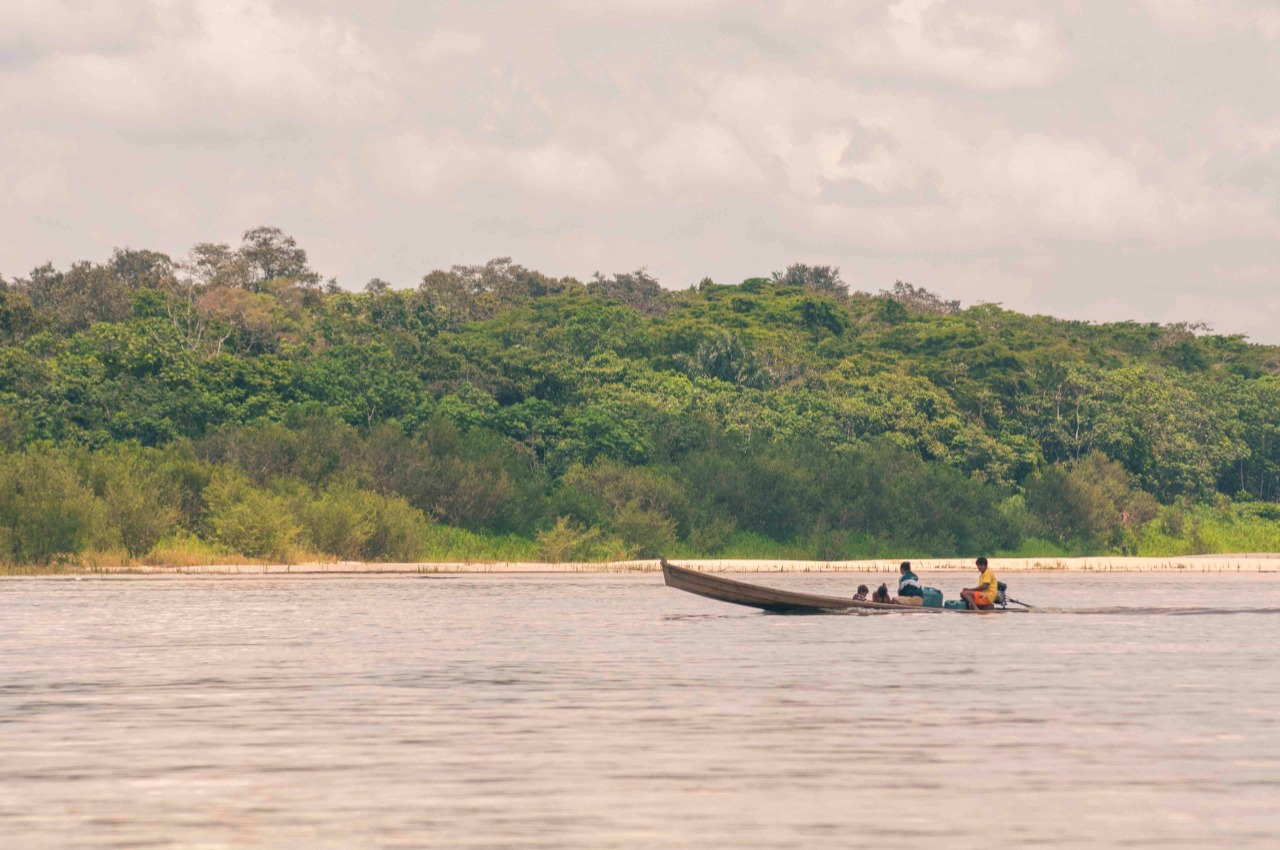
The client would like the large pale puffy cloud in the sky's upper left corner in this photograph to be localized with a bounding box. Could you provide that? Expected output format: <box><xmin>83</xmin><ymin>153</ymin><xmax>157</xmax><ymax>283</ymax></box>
<box><xmin>0</xmin><ymin>0</ymin><xmax>396</xmax><ymax>129</ymax></box>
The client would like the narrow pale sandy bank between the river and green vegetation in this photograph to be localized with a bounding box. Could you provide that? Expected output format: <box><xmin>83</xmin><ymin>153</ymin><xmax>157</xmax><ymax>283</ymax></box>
<box><xmin>30</xmin><ymin>554</ymin><xmax>1280</xmax><ymax>575</ymax></box>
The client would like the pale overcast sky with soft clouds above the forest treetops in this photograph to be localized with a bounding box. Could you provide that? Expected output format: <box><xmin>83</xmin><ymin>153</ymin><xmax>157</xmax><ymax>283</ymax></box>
<box><xmin>0</xmin><ymin>0</ymin><xmax>1280</xmax><ymax>342</ymax></box>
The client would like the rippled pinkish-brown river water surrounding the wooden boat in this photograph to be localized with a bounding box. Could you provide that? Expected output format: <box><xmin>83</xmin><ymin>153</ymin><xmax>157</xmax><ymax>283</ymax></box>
<box><xmin>0</xmin><ymin>573</ymin><xmax>1280</xmax><ymax>850</ymax></box>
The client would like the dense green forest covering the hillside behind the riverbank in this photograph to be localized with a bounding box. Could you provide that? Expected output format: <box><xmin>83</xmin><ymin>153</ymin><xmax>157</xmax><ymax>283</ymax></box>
<box><xmin>0</xmin><ymin>228</ymin><xmax>1280</xmax><ymax>565</ymax></box>
